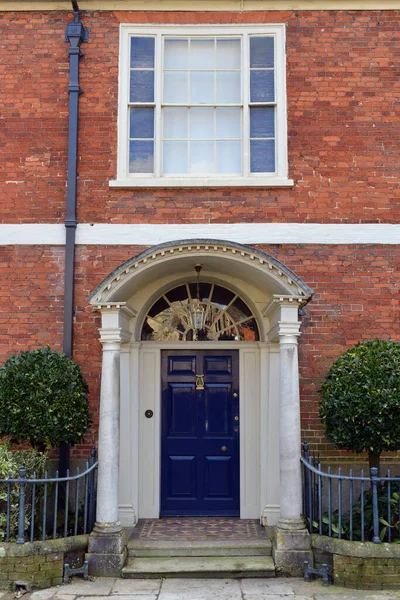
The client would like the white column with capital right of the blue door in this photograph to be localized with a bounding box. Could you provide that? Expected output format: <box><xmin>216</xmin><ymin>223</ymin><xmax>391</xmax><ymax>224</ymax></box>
<box><xmin>264</xmin><ymin>296</ymin><xmax>304</xmax><ymax>529</ymax></box>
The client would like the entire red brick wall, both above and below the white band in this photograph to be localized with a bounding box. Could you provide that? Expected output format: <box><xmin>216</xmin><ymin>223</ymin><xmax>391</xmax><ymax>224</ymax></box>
<box><xmin>0</xmin><ymin>10</ymin><xmax>400</xmax><ymax>459</ymax></box>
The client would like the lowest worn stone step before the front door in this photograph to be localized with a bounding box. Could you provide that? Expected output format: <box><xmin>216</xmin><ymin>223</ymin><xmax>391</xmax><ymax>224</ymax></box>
<box><xmin>122</xmin><ymin>556</ymin><xmax>275</xmax><ymax>579</ymax></box>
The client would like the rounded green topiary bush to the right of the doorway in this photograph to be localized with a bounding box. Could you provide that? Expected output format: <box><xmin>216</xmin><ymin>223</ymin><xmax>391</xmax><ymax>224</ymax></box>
<box><xmin>320</xmin><ymin>340</ymin><xmax>400</xmax><ymax>469</ymax></box>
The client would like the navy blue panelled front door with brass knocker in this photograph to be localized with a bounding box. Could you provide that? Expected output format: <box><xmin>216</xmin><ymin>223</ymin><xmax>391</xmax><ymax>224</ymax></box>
<box><xmin>161</xmin><ymin>350</ymin><xmax>240</xmax><ymax>516</ymax></box>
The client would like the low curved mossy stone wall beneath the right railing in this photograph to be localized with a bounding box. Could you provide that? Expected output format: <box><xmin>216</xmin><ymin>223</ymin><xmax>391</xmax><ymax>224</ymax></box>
<box><xmin>312</xmin><ymin>535</ymin><xmax>400</xmax><ymax>590</ymax></box>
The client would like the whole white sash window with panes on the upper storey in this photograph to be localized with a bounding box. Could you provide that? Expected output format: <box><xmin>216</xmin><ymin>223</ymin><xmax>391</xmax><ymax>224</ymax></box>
<box><xmin>111</xmin><ymin>25</ymin><xmax>292</xmax><ymax>186</ymax></box>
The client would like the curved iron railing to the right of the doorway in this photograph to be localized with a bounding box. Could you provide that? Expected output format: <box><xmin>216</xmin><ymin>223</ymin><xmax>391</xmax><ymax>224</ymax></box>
<box><xmin>301</xmin><ymin>442</ymin><xmax>400</xmax><ymax>544</ymax></box>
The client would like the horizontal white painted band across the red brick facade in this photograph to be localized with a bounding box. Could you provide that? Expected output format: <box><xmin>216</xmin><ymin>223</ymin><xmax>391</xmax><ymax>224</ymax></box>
<box><xmin>0</xmin><ymin>223</ymin><xmax>400</xmax><ymax>246</ymax></box>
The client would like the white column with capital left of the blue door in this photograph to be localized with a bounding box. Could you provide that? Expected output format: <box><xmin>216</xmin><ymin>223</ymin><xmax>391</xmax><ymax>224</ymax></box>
<box><xmin>94</xmin><ymin>303</ymin><xmax>133</xmax><ymax>533</ymax></box>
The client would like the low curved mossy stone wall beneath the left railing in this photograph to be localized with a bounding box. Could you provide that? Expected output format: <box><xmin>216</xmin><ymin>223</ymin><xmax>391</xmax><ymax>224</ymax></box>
<box><xmin>0</xmin><ymin>535</ymin><xmax>88</xmax><ymax>590</ymax></box>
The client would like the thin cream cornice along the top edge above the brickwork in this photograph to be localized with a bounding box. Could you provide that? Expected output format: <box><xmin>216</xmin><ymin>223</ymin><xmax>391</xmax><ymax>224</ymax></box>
<box><xmin>0</xmin><ymin>0</ymin><xmax>400</xmax><ymax>12</ymax></box>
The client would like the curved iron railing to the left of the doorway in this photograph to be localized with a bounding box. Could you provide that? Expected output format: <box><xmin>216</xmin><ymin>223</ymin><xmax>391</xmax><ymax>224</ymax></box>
<box><xmin>0</xmin><ymin>448</ymin><xmax>98</xmax><ymax>544</ymax></box>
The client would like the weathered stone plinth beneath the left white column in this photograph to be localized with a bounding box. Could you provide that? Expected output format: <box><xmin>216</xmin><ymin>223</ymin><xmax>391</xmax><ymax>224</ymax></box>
<box><xmin>85</xmin><ymin>523</ymin><xmax>127</xmax><ymax>577</ymax></box>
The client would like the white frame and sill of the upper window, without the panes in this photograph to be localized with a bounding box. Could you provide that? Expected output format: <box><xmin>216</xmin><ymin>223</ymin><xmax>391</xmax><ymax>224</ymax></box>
<box><xmin>109</xmin><ymin>23</ymin><xmax>294</xmax><ymax>188</ymax></box>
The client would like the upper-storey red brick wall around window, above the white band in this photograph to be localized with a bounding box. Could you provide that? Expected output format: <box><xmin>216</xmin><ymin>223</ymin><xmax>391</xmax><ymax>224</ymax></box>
<box><xmin>0</xmin><ymin>11</ymin><xmax>400</xmax><ymax>223</ymax></box>
